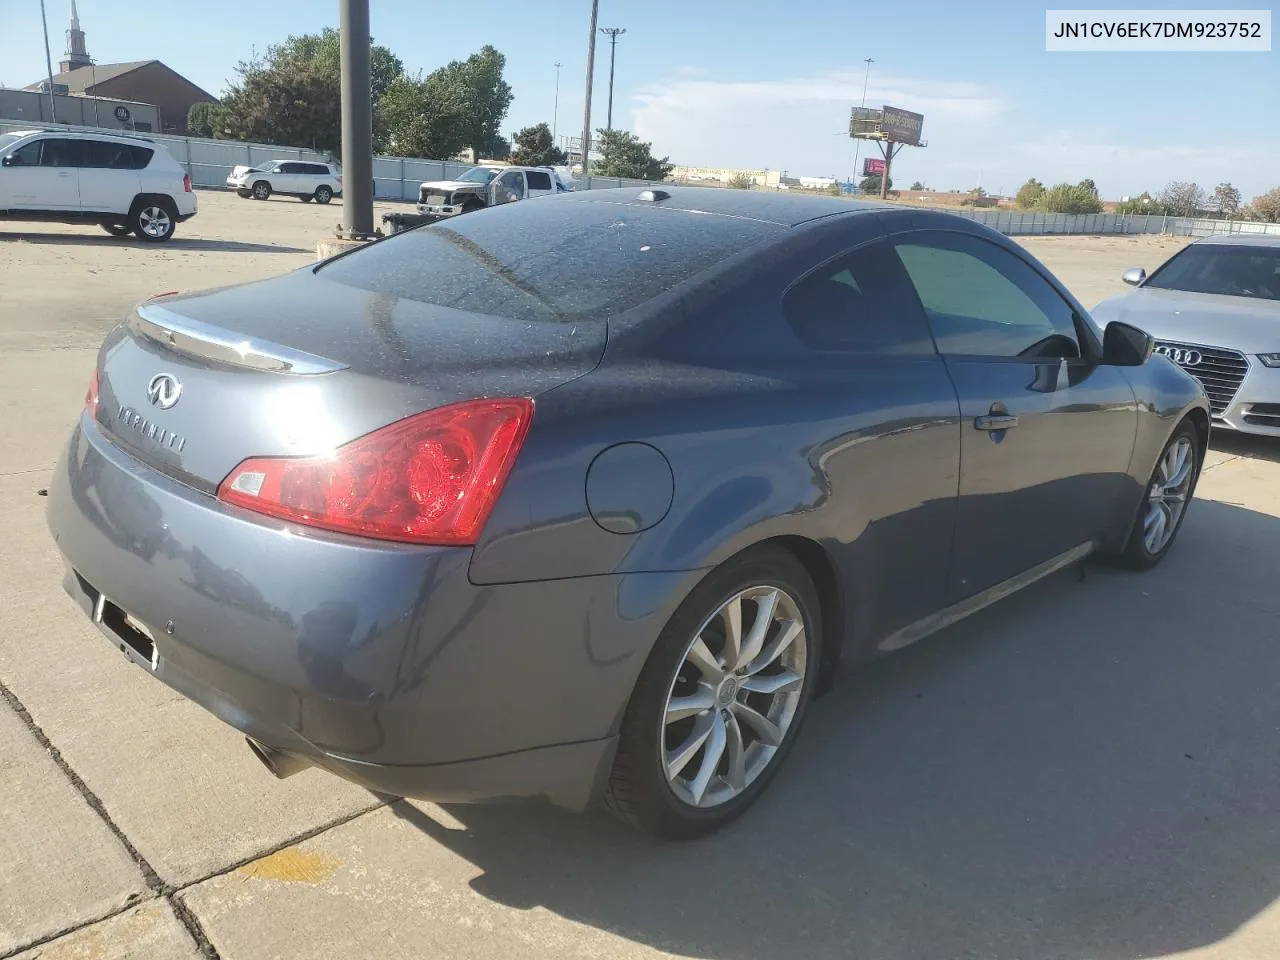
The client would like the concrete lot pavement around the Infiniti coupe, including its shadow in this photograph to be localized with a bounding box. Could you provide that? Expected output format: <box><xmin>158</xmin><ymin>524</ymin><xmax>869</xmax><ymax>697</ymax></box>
<box><xmin>0</xmin><ymin>195</ymin><xmax>1280</xmax><ymax>960</ymax></box>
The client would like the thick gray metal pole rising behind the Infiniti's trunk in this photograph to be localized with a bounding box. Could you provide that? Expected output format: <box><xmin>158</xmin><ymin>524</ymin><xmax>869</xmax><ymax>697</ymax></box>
<box><xmin>338</xmin><ymin>0</ymin><xmax>374</xmax><ymax>239</ymax></box>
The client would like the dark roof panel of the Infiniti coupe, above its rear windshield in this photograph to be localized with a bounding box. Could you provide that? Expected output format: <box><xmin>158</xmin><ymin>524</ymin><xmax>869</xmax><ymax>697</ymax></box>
<box><xmin>557</xmin><ymin>183</ymin><xmax>900</xmax><ymax>227</ymax></box>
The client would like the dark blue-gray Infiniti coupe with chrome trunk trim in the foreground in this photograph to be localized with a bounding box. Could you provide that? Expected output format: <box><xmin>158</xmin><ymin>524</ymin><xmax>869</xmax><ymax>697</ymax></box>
<box><xmin>49</xmin><ymin>188</ymin><xmax>1210</xmax><ymax>838</ymax></box>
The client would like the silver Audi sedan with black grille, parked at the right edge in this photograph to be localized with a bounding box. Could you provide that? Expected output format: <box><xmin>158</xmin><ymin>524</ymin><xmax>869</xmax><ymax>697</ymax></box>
<box><xmin>1093</xmin><ymin>234</ymin><xmax>1280</xmax><ymax>436</ymax></box>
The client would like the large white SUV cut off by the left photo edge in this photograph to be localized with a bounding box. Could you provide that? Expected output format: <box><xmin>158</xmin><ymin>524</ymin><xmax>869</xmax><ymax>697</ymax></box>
<box><xmin>0</xmin><ymin>131</ymin><xmax>196</xmax><ymax>243</ymax></box>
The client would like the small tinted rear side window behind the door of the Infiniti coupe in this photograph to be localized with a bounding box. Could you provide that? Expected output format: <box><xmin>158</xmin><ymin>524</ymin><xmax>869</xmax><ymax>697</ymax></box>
<box><xmin>782</xmin><ymin>241</ymin><xmax>934</xmax><ymax>355</ymax></box>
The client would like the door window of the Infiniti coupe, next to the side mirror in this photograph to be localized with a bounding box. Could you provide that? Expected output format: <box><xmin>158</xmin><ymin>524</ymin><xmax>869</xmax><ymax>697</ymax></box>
<box><xmin>895</xmin><ymin>232</ymin><xmax>1082</xmax><ymax>361</ymax></box>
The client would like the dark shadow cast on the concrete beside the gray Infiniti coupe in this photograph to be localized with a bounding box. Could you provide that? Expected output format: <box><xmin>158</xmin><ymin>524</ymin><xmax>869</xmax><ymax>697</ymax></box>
<box><xmin>393</xmin><ymin>500</ymin><xmax>1280</xmax><ymax>960</ymax></box>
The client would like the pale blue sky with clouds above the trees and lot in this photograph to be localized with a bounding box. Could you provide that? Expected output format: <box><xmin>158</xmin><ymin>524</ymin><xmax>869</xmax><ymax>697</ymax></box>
<box><xmin>0</xmin><ymin>0</ymin><xmax>1280</xmax><ymax>198</ymax></box>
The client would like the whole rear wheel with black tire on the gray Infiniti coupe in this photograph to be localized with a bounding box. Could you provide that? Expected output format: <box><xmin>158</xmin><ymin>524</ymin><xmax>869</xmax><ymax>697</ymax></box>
<box><xmin>604</xmin><ymin>547</ymin><xmax>822</xmax><ymax>840</ymax></box>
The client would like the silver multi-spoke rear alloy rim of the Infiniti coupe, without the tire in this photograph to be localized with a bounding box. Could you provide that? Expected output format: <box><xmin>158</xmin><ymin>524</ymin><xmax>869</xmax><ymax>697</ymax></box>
<box><xmin>659</xmin><ymin>585</ymin><xmax>808</xmax><ymax>808</ymax></box>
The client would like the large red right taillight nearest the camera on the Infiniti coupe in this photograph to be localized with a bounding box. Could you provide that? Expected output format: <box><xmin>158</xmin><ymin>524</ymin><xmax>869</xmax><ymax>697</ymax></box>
<box><xmin>218</xmin><ymin>398</ymin><xmax>534</xmax><ymax>545</ymax></box>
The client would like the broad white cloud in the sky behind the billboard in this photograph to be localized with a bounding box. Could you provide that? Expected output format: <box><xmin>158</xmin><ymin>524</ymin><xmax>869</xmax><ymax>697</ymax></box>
<box><xmin>632</xmin><ymin>68</ymin><xmax>1007</xmax><ymax>174</ymax></box>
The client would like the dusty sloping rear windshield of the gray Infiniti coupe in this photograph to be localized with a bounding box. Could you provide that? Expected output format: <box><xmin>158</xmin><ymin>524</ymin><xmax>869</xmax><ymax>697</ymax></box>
<box><xmin>321</xmin><ymin>196</ymin><xmax>785</xmax><ymax>321</ymax></box>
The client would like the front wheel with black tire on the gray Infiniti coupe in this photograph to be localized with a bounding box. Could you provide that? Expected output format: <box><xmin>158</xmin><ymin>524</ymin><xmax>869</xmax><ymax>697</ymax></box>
<box><xmin>1115</xmin><ymin>420</ymin><xmax>1203</xmax><ymax>570</ymax></box>
